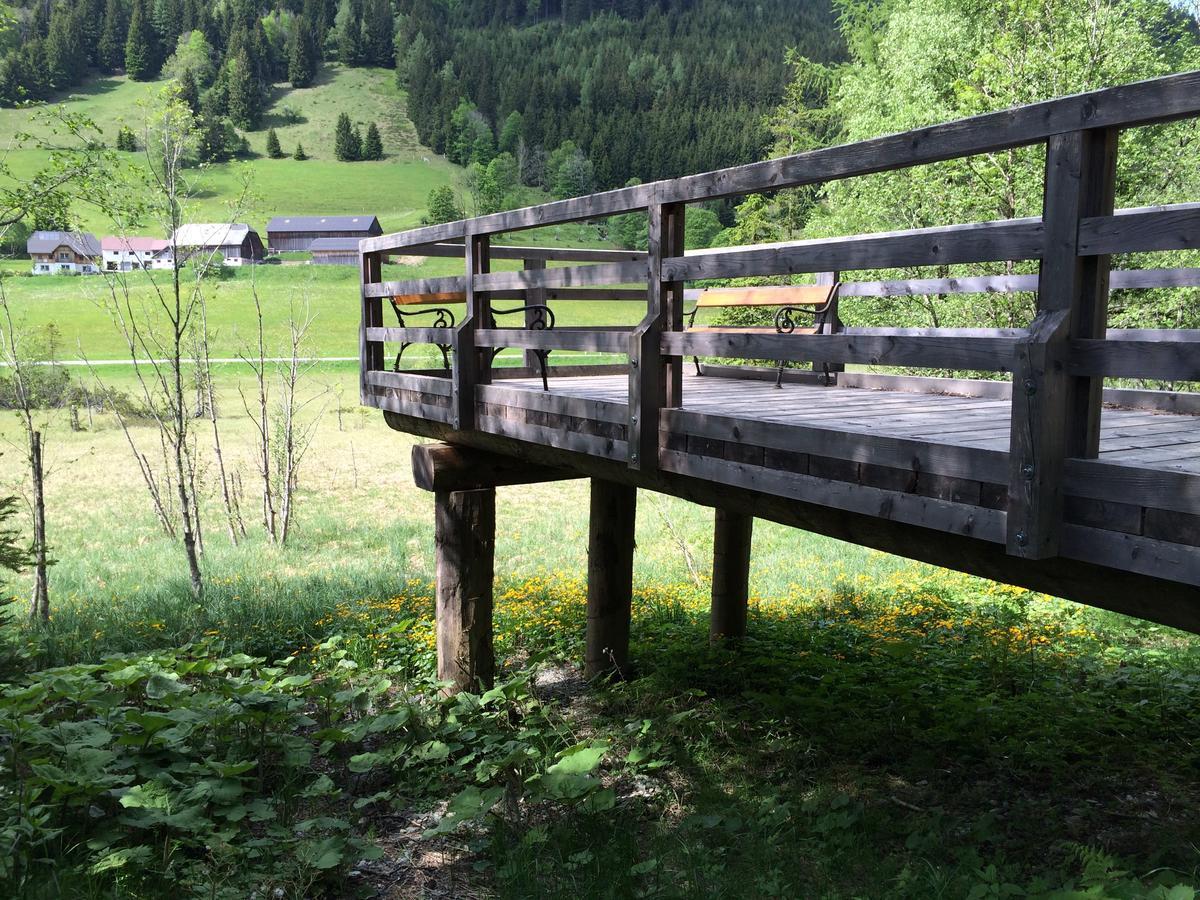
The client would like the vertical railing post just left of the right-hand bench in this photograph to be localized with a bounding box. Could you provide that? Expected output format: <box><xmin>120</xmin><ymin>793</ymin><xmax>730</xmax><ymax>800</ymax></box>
<box><xmin>628</xmin><ymin>203</ymin><xmax>684</xmax><ymax>472</ymax></box>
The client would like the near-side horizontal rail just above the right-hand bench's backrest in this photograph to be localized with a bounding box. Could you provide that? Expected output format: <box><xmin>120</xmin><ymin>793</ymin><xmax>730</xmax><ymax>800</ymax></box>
<box><xmin>662</xmin><ymin>218</ymin><xmax>1044</xmax><ymax>281</ymax></box>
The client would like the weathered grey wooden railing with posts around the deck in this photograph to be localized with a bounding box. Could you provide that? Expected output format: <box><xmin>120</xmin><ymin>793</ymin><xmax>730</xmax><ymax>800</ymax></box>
<box><xmin>360</xmin><ymin>72</ymin><xmax>1200</xmax><ymax>558</ymax></box>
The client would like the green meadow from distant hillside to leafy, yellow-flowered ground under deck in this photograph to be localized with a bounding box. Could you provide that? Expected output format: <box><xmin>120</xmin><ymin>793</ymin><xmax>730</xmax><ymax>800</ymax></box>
<box><xmin>0</xmin><ymin>66</ymin><xmax>1200</xmax><ymax>900</ymax></box>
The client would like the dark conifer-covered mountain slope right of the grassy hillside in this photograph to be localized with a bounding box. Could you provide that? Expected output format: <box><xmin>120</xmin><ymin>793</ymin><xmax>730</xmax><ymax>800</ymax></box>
<box><xmin>396</xmin><ymin>0</ymin><xmax>844</xmax><ymax>188</ymax></box>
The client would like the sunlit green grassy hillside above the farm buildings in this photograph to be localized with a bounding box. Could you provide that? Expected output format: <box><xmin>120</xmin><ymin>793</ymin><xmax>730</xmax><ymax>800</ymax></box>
<box><xmin>0</xmin><ymin>65</ymin><xmax>462</xmax><ymax>238</ymax></box>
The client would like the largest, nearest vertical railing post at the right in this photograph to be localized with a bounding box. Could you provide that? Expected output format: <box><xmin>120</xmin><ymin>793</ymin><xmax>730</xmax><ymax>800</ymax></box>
<box><xmin>1007</xmin><ymin>128</ymin><xmax>1118</xmax><ymax>559</ymax></box>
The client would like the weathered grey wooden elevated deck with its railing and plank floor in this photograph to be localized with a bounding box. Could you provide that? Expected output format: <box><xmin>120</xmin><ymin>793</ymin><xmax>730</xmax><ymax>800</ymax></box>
<box><xmin>360</xmin><ymin>72</ymin><xmax>1200</xmax><ymax>691</ymax></box>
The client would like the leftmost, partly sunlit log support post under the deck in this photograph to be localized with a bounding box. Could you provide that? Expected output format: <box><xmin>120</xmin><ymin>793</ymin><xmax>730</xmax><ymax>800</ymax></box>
<box><xmin>434</xmin><ymin>487</ymin><xmax>496</xmax><ymax>694</ymax></box>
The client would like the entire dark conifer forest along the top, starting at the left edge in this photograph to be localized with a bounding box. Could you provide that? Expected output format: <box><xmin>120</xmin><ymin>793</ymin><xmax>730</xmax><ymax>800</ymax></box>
<box><xmin>0</xmin><ymin>0</ymin><xmax>844</xmax><ymax>190</ymax></box>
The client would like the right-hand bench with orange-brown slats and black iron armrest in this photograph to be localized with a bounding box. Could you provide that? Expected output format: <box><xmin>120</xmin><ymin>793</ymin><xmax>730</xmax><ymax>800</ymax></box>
<box><xmin>684</xmin><ymin>281</ymin><xmax>841</xmax><ymax>388</ymax></box>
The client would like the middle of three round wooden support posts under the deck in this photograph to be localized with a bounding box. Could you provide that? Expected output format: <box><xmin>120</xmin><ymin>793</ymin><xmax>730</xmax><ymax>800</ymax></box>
<box><xmin>583</xmin><ymin>479</ymin><xmax>637</xmax><ymax>678</ymax></box>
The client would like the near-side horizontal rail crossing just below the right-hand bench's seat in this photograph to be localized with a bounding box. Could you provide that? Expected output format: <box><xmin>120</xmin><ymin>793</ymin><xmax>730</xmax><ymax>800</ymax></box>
<box><xmin>662</xmin><ymin>331</ymin><xmax>1016</xmax><ymax>372</ymax></box>
